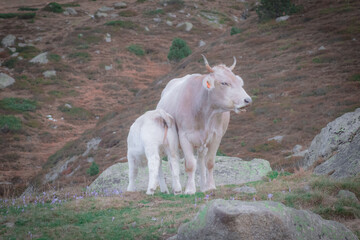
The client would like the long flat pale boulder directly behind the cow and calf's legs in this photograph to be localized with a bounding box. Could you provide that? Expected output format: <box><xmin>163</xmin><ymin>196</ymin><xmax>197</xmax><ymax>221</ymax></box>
<box><xmin>88</xmin><ymin>156</ymin><xmax>271</xmax><ymax>192</ymax></box>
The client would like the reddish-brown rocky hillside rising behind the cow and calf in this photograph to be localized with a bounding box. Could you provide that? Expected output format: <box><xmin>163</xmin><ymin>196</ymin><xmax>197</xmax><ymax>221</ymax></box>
<box><xmin>0</xmin><ymin>0</ymin><xmax>360</xmax><ymax>195</ymax></box>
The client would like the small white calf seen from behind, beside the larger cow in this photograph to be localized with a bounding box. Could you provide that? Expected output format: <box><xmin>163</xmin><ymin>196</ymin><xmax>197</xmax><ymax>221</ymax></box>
<box><xmin>127</xmin><ymin>109</ymin><xmax>182</xmax><ymax>194</ymax></box>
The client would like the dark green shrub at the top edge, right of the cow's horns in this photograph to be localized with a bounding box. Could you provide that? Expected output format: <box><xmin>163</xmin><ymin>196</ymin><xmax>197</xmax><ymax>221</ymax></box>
<box><xmin>256</xmin><ymin>0</ymin><xmax>300</xmax><ymax>21</ymax></box>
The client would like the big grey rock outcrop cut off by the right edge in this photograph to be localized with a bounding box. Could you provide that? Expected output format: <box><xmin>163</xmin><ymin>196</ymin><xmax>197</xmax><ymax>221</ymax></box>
<box><xmin>299</xmin><ymin>108</ymin><xmax>360</xmax><ymax>178</ymax></box>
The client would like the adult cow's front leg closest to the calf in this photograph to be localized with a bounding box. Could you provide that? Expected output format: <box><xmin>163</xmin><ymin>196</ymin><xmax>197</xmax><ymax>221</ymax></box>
<box><xmin>180</xmin><ymin>137</ymin><xmax>196</xmax><ymax>194</ymax></box>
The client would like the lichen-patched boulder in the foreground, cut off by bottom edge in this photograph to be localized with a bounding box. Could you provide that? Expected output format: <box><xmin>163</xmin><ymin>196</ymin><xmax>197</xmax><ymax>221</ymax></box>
<box><xmin>172</xmin><ymin>199</ymin><xmax>358</xmax><ymax>240</ymax></box>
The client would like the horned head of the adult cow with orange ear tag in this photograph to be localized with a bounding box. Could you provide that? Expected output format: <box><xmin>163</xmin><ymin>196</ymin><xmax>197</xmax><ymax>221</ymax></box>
<box><xmin>202</xmin><ymin>55</ymin><xmax>252</xmax><ymax>113</ymax></box>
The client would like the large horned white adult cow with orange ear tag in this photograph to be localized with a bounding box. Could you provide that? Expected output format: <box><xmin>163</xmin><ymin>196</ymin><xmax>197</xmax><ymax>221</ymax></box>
<box><xmin>157</xmin><ymin>56</ymin><xmax>252</xmax><ymax>194</ymax></box>
